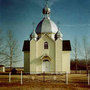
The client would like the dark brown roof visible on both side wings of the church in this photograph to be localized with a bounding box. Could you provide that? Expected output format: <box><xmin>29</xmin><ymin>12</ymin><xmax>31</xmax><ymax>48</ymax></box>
<box><xmin>22</xmin><ymin>40</ymin><xmax>71</xmax><ymax>51</ymax></box>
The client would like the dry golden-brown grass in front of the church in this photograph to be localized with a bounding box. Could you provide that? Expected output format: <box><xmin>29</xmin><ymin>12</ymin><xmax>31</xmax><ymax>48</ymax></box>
<box><xmin>0</xmin><ymin>74</ymin><xmax>90</xmax><ymax>90</ymax></box>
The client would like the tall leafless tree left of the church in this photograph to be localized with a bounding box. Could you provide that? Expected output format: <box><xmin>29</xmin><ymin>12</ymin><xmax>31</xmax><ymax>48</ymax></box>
<box><xmin>0</xmin><ymin>30</ymin><xmax>20</xmax><ymax>69</ymax></box>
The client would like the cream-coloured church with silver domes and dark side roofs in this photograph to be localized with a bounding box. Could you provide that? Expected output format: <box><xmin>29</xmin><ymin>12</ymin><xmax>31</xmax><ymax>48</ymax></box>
<box><xmin>23</xmin><ymin>1</ymin><xmax>71</xmax><ymax>74</ymax></box>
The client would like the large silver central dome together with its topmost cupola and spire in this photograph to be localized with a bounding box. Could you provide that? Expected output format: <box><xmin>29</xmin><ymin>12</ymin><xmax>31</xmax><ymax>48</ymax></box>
<box><xmin>36</xmin><ymin>0</ymin><xmax>58</xmax><ymax>34</ymax></box>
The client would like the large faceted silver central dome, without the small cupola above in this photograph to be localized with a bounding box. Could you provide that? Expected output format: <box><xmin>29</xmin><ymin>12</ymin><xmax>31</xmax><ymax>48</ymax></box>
<box><xmin>36</xmin><ymin>17</ymin><xmax>58</xmax><ymax>34</ymax></box>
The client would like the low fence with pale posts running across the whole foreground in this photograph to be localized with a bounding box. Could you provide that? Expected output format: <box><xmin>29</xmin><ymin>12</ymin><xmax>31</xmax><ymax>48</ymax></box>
<box><xmin>0</xmin><ymin>71</ymin><xmax>90</xmax><ymax>85</ymax></box>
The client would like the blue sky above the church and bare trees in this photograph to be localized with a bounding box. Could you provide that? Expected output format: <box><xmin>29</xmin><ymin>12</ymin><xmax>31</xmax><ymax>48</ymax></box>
<box><xmin>0</xmin><ymin>0</ymin><xmax>90</xmax><ymax>66</ymax></box>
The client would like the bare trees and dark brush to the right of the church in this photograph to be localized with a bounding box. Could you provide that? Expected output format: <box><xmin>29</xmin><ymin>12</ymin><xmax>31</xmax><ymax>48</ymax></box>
<box><xmin>71</xmin><ymin>36</ymin><xmax>90</xmax><ymax>72</ymax></box>
